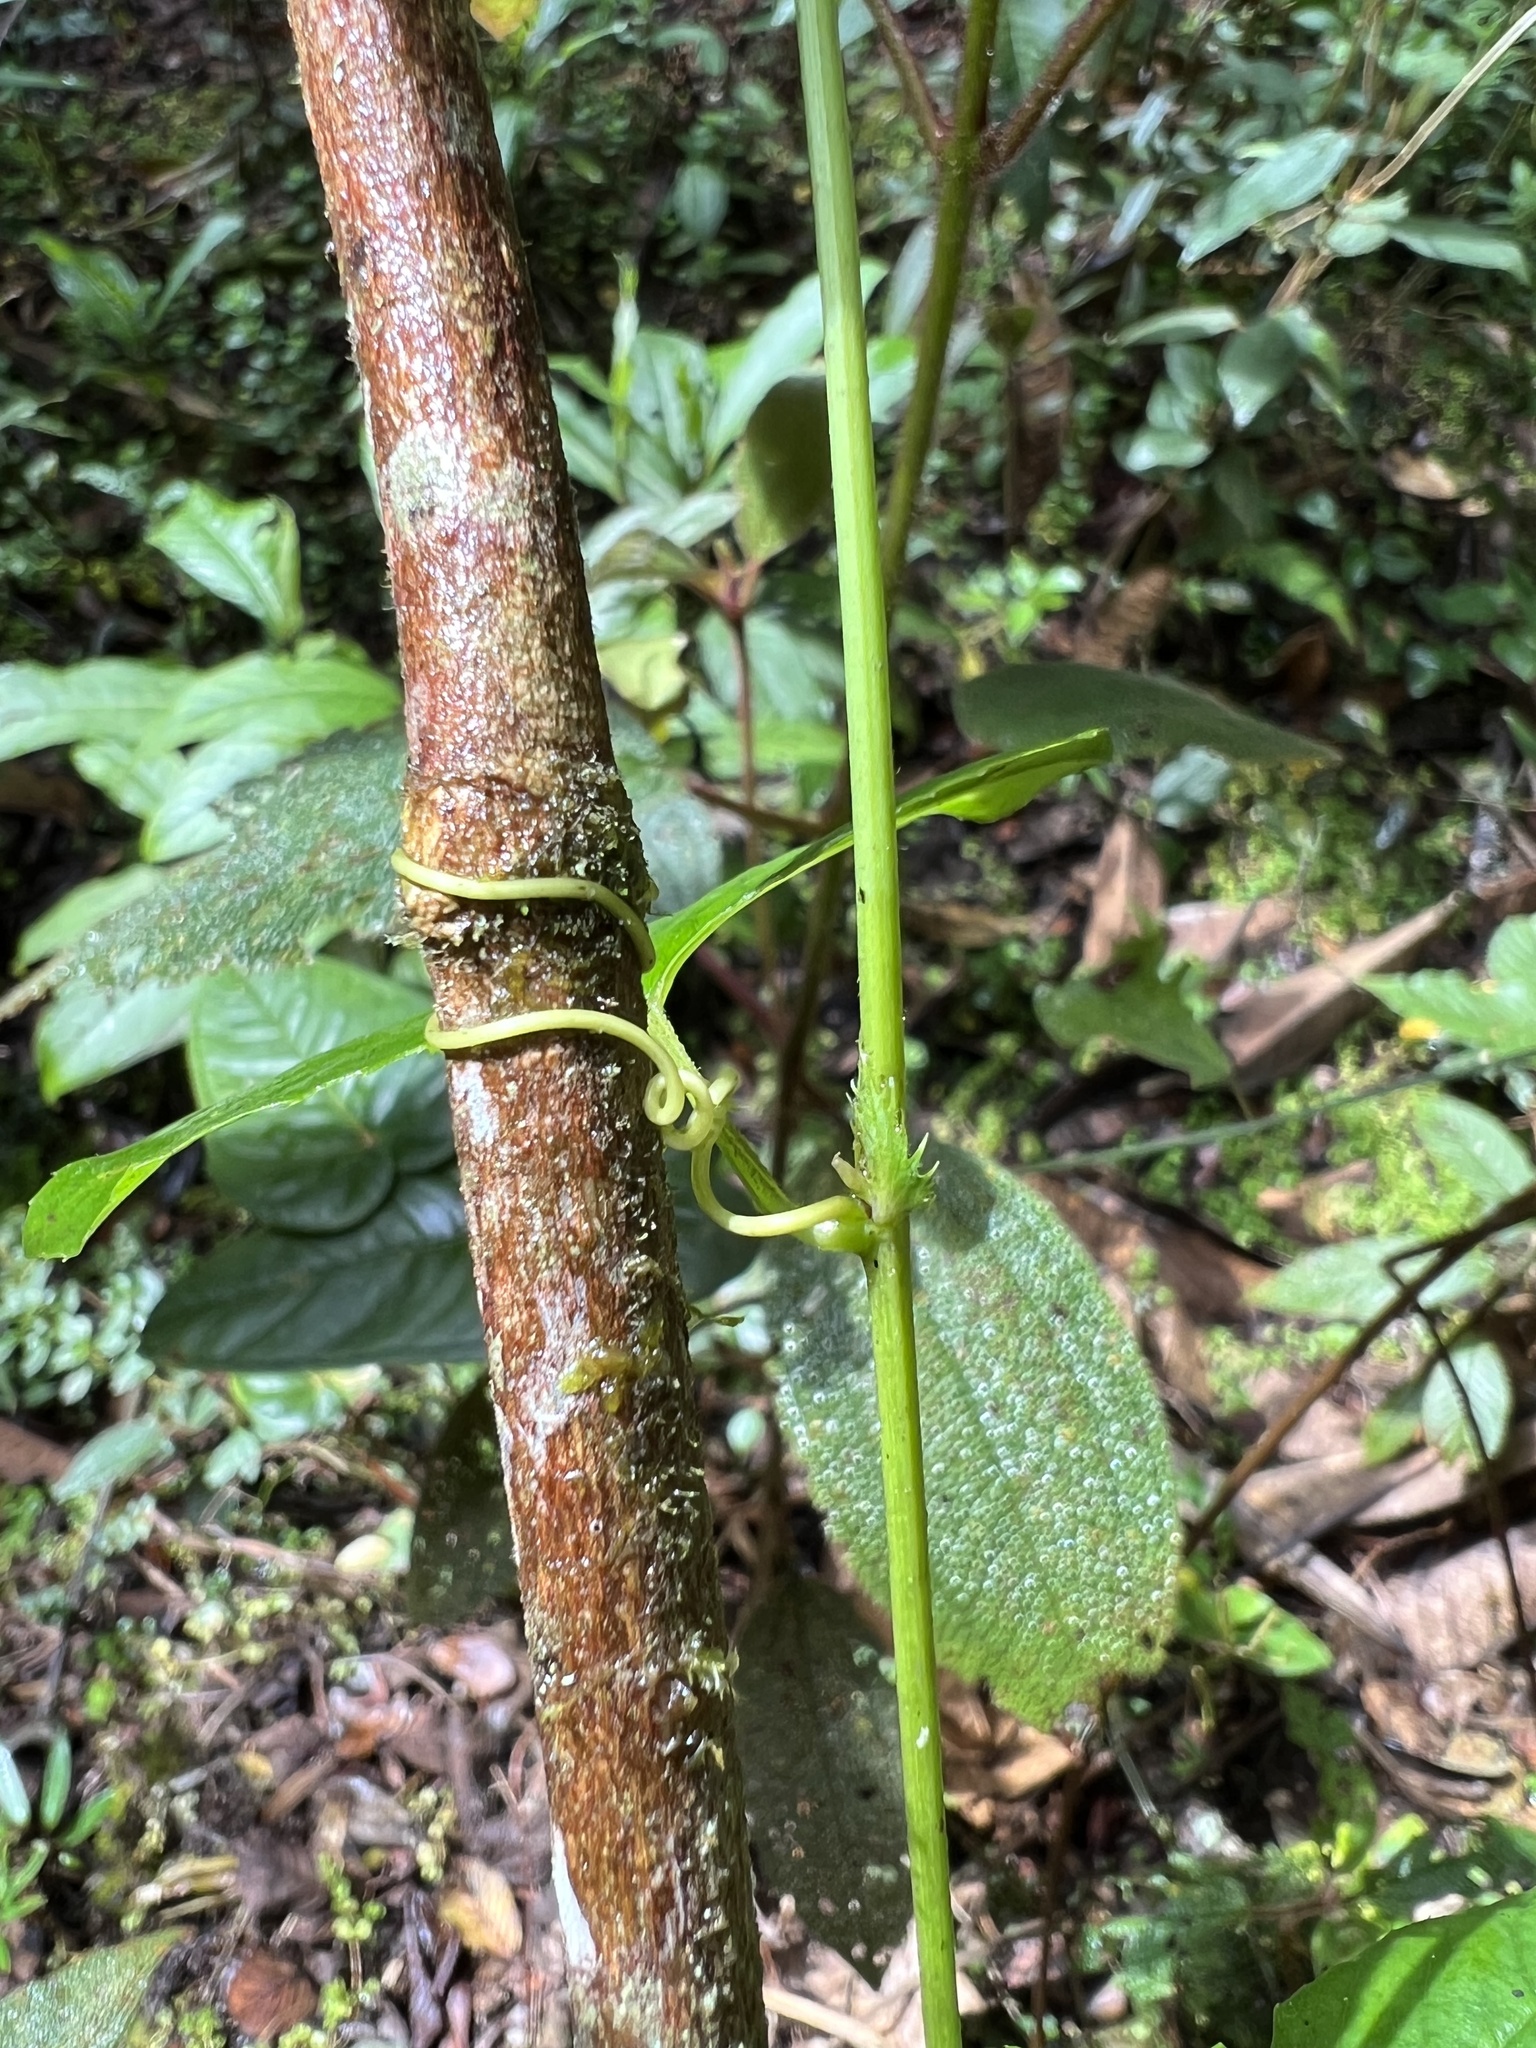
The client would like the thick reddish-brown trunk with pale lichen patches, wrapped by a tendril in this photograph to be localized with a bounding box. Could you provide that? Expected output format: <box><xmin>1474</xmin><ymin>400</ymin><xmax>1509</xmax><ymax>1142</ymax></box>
<box><xmin>291</xmin><ymin>0</ymin><xmax>766</xmax><ymax>2048</ymax></box>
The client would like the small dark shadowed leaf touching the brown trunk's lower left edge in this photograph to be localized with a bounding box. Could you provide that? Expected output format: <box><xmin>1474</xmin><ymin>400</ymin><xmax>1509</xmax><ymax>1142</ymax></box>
<box><xmin>406</xmin><ymin>1380</ymin><xmax>518</xmax><ymax>1628</ymax></box>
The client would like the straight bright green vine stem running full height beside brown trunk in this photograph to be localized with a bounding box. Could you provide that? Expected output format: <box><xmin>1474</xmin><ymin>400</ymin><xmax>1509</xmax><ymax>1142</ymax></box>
<box><xmin>799</xmin><ymin>0</ymin><xmax>962</xmax><ymax>2048</ymax></box>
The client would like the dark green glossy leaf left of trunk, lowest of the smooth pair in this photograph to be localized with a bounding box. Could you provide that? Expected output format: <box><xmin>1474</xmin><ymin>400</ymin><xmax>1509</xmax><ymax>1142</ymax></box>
<box><xmin>139</xmin><ymin>1176</ymin><xmax>485</xmax><ymax>1372</ymax></box>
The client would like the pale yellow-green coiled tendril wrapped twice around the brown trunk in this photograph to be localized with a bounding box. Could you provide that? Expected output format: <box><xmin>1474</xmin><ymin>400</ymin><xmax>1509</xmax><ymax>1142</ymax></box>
<box><xmin>389</xmin><ymin>852</ymin><xmax>874</xmax><ymax>1255</ymax></box>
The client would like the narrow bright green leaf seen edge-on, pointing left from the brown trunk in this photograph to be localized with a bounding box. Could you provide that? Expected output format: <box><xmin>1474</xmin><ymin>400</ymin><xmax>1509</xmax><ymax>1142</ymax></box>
<box><xmin>25</xmin><ymin>1010</ymin><xmax>430</xmax><ymax>1260</ymax></box>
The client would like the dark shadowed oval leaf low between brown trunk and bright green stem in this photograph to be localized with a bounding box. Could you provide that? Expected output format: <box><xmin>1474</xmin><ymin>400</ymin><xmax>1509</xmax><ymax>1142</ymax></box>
<box><xmin>735</xmin><ymin>1575</ymin><xmax>911</xmax><ymax>1966</ymax></box>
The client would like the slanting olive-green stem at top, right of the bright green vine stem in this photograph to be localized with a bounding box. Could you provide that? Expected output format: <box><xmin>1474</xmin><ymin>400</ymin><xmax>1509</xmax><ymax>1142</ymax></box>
<box><xmin>883</xmin><ymin>0</ymin><xmax>997</xmax><ymax>592</ymax></box>
